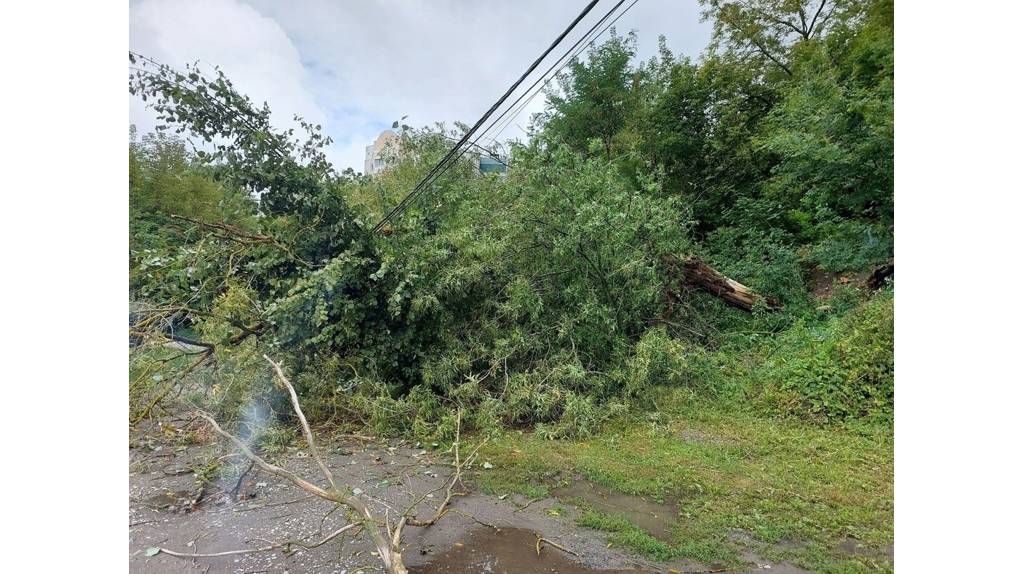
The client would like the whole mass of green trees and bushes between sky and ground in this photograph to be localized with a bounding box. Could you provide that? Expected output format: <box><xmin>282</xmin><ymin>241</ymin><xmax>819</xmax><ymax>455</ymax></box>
<box><xmin>129</xmin><ymin>0</ymin><xmax>893</xmax><ymax>437</ymax></box>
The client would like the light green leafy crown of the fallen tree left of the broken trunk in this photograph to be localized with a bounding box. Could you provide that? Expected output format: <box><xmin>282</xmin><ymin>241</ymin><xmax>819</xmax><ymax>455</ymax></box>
<box><xmin>346</xmin><ymin>148</ymin><xmax>690</xmax><ymax>436</ymax></box>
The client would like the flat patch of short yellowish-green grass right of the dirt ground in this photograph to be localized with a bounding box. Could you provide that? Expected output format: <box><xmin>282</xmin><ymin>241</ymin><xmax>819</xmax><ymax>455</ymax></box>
<box><xmin>468</xmin><ymin>401</ymin><xmax>893</xmax><ymax>572</ymax></box>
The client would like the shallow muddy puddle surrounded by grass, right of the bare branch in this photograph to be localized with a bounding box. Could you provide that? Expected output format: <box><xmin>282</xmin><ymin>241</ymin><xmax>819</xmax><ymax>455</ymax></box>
<box><xmin>551</xmin><ymin>480</ymin><xmax>677</xmax><ymax>542</ymax></box>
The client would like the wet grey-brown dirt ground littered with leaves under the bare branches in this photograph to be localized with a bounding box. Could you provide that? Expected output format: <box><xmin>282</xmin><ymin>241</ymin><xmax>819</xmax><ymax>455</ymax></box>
<box><xmin>128</xmin><ymin>421</ymin><xmax>805</xmax><ymax>574</ymax></box>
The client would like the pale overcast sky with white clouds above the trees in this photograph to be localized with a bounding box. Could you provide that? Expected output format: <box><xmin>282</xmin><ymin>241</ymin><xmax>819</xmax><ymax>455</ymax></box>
<box><xmin>129</xmin><ymin>0</ymin><xmax>711</xmax><ymax>171</ymax></box>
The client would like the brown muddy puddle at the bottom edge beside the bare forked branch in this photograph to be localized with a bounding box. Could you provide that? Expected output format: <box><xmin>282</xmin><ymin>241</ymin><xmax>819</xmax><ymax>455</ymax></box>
<box><xmin>409</xmin><ymin>528</ymin><xmax>643</xmax><ymax>574</ymax></box>
